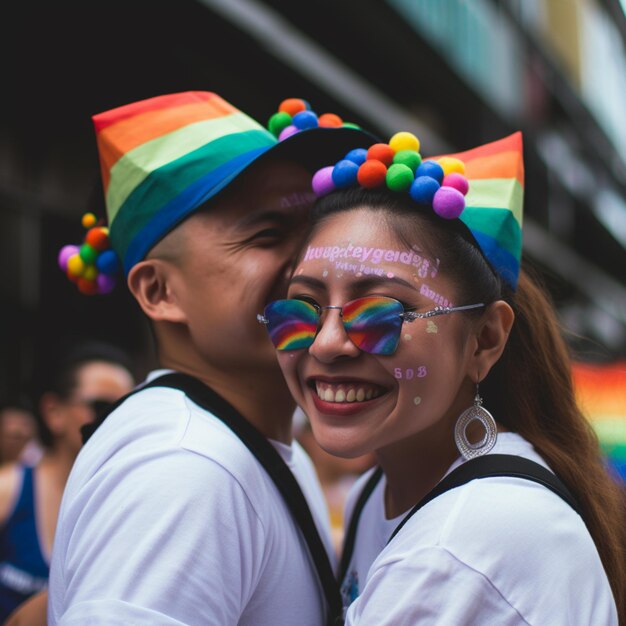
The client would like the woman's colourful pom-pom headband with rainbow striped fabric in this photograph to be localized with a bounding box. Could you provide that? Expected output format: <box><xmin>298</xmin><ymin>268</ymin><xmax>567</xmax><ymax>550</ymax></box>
<box><xmin>312</xmin><ymin>131</ymin><xmax>524</xmax><ymax>290</ymax></box>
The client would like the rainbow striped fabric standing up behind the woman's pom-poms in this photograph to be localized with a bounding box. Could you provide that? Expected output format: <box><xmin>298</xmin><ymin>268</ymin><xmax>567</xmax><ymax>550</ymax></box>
<box><xmin>430</xmin><ymin>131</ymin><xmax>524</xmax><ymax>289</ymax></box>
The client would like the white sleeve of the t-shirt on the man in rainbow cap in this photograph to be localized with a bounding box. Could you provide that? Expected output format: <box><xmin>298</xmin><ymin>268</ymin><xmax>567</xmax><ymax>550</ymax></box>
<box><xmin>49</xmin><ymin>450</ymin><xmax>266</xmax><ymax>626</ymax></box>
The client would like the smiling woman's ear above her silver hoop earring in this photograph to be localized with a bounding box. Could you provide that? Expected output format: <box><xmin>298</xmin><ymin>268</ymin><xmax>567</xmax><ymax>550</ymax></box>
<box><xmin>470</xmin><ymin>300</ymin><xmax>515</xmax><ymax>382</ymax></box>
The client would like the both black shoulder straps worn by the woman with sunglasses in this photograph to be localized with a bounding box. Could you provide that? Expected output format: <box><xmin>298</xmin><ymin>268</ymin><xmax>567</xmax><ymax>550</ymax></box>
<box><xmin>339</xmin><ymin>454</ymin><xmax>580</xmax><ymax>582</ymax></box>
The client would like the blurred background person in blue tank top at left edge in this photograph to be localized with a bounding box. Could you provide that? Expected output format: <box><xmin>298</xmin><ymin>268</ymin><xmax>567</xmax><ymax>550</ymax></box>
<box><xmin>0</xmin><ymin>342</ymin><xmax>134</xmax><ymax>622</ymax></box>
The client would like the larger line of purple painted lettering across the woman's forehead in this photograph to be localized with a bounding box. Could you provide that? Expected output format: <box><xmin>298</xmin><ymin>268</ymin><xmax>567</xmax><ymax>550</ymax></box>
<box><xmin>302</xmin><ymin>243</ymin><xmax>439</xmax><ymax>278</ymax></box>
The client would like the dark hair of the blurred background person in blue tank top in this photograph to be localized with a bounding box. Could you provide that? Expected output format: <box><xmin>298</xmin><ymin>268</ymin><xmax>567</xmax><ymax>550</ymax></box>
<box><xmin>37</xmin><ymin>340</ymin><xmax>135</xmax><ymax>447</ymax></box>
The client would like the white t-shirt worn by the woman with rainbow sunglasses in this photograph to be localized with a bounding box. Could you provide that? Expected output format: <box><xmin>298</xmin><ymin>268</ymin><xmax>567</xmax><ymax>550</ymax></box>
<box><xmin>343</xmin><ymin>433</ymin><xmax>617</xmax><ymax>626</ymax></box>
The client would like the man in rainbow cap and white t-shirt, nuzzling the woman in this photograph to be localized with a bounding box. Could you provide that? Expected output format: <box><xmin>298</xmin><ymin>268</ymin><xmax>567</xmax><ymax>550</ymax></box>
<box><xmin>48</xmin><ymin>92</ymin><xmax>372</xmax><ymax>626</ymax></box>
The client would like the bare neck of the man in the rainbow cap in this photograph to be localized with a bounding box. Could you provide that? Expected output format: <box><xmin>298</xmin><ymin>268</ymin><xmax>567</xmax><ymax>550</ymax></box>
<box><xmin>156</xmin><ymin>356</ymin><xmax>295</xmax><ymax>444</ymax></box>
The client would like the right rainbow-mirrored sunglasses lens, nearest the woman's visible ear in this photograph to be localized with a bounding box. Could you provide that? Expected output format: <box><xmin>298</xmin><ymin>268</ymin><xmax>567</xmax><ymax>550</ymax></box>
<box><xmin>343</xmin><ymin>296</ymin><xmax>404</xmax><ymax>354</ymax></box>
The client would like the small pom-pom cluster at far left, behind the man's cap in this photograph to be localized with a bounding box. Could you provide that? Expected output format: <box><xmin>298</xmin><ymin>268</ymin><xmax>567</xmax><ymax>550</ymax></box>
<box><xmin>57</xmin><ymin>213</ymin><xmax>120</xmax><ymax>296</ymax></box>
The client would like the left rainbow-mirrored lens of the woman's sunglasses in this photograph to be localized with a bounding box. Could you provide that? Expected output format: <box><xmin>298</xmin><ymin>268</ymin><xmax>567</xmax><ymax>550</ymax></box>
<box><xmin>265</xmin><ymin>300</ymin><xmax>319</xmax><ymax>350</ymax></box>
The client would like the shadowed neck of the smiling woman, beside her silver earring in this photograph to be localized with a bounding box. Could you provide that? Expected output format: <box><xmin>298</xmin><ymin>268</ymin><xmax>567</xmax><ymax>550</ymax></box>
<box><xmin>376</xmin><ymin>429</ymin><xmax>459</xmax><ymax>519</ymax></box>
